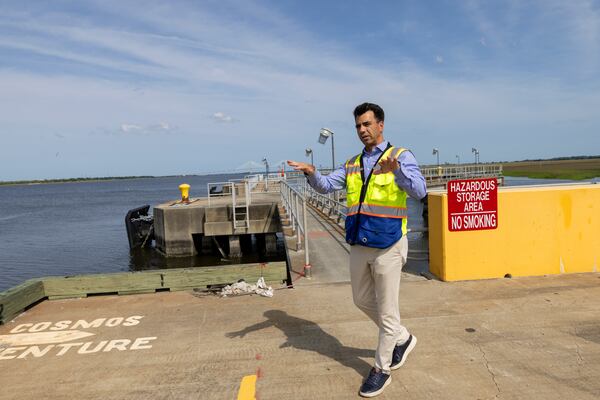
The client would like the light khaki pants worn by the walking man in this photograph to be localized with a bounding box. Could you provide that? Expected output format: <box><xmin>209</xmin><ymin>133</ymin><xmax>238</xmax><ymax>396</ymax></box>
<box><xmin>350</xmin><ymin>236</ymin><xmax>410</xmax><ymax>373</ymax></box>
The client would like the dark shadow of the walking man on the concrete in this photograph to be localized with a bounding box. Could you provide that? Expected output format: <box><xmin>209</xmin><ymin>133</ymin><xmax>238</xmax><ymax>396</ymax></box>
<box><xmin>226</xmin><ymin>310</ymin><xmax>375</xmax><ymax>376</ymax></box>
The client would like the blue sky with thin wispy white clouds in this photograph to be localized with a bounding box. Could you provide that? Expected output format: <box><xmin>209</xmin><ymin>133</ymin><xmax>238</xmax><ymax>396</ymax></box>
<box><xmin>0</xmin><ymin>0</ymin><xmax>600</xmax><ymax>181</ymax></box>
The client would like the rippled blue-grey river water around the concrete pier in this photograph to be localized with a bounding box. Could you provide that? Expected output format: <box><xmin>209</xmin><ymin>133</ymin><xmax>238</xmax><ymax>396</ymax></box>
<box><xmin>0</xmin><ymin>175</ymin><xmax>592</xmax><ymax>291</ymax></box>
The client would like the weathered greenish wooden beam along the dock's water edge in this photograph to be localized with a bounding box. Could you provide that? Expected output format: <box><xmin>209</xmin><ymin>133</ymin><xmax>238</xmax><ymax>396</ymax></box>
<box><xmin>0</xmin><ymin>261</ymin><xmax>291</xmax><ymax>325</ymax></box>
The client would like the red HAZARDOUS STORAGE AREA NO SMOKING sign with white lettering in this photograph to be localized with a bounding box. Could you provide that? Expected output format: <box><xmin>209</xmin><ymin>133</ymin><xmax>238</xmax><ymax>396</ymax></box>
<box><xmin>448</xmin><ymin>178</ymin><xmax>498</xmax><ymax>232</ymax></box>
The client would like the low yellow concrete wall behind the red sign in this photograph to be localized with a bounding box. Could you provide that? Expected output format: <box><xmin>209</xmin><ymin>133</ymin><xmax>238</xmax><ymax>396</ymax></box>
<box><xmin>428</xmin><ymin>184</ymin><xmax>600</xmax><ymax>281</ymax></box>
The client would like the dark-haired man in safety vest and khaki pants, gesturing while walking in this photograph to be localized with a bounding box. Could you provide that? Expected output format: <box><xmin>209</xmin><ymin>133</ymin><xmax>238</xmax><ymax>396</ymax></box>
<box><xmin>288</xmin><ymin>103</ymin><xmax>427</xmax><ymax>397</ymax></box>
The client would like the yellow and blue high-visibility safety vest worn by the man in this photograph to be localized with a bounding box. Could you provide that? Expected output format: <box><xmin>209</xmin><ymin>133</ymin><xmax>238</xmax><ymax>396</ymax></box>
<box><xmin>346</xmin><ymin>145</ymin><xmax>407</xmax><ymax>248</ymax></box>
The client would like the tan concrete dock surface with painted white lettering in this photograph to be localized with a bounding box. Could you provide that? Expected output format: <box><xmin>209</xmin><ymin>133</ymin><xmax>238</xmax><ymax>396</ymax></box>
<box><xmin>0</xmin><ymin>273</ymin><xmax>600</xmax><ymax>400</ymax></box>
